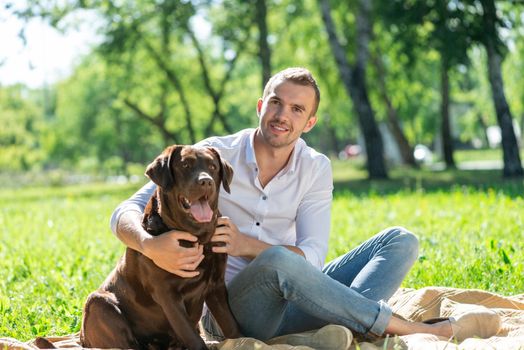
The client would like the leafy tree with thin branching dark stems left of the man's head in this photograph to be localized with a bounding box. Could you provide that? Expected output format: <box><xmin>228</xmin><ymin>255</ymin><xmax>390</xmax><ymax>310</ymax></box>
<box><xmin>13</xmin><ymin>0</ymin><xmax>253</xmax><ymax>144</ymax></box>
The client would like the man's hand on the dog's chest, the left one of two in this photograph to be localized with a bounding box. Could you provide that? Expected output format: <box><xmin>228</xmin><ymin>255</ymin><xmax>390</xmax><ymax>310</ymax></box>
<box><xmin>142</xmin><ymin>231</ymin><xmax>204</xmax><ymax>278</ymax></box>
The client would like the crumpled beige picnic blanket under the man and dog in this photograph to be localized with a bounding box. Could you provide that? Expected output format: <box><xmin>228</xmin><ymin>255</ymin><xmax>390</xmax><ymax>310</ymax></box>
<box><xmin>4</xmin><ymin>287</ymin><xmax>524</xmax><ymax>350</ymax></box>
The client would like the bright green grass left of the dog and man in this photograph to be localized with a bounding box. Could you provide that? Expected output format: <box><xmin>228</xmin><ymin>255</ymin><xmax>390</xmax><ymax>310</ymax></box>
<box><xmin>0</xmin><ymin>185</ymin><xmax>141</xmax><ymax>340</ymax></box>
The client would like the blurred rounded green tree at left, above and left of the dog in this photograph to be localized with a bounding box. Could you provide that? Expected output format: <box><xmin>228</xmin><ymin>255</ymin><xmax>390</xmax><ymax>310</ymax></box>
<box><xmin>51</xmin><ymin>55</ymin><xmax>162</xmax><ymax>174</ymax></box>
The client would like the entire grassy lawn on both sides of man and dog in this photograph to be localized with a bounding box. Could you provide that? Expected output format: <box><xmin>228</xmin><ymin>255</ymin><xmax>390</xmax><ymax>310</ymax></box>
<box><xmin>0</xmin><ymin>162</ymin><xmax>524</xmax><ymax>340</ymax></box>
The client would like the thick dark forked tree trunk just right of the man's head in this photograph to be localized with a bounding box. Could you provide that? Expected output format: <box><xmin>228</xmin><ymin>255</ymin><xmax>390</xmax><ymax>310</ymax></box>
<box><xmin>319</xmin><ymin>0</ymin><xmax>388</xmax><ymax>179</ymax></box>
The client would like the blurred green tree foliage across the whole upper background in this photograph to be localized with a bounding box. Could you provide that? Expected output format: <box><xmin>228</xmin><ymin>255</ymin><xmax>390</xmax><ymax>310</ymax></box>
<box><xmin>0</xmin><ymin>0</ymin><xmax>524</xmax><ymax>176</ymax></box>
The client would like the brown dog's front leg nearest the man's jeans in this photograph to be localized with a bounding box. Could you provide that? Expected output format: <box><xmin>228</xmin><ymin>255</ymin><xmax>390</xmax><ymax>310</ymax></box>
<box><xmin>206</xmin><ymin>282</ymin><xmax>242</xmax><ymax>339</ymax></box>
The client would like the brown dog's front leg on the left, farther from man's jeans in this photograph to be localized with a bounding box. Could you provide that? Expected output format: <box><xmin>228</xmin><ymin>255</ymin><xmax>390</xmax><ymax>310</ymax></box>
<box><xmin>154</xmin><ymin>291</ymin><xmax>207</xmax><ymax>350</ymax></box>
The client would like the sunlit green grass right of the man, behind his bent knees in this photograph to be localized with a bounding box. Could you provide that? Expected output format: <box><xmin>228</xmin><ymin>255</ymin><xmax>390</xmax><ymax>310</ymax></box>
<box><xmin>328</xmin><ymin>189</ymin><xmax>524</xmax><ymax>294</ymax></box>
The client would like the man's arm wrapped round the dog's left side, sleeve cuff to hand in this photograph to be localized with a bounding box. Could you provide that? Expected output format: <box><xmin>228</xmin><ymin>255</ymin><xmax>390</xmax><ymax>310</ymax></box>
<box><xmin>111</xmin><ymin>183</ymin><xmax>204</xmax><ymax>277</ymax></box>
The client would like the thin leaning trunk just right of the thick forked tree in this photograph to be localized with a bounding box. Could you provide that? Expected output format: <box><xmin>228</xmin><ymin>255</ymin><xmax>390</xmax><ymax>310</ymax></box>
<box><xmin>372</xmin><ymin>54</ymin><xmax>417</xmax><ymax>166</ymax></box>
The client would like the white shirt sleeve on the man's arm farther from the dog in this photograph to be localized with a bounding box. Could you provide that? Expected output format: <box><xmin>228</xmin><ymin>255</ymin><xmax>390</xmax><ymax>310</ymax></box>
<box><xmin>296</xmin><ymin>159</ymin><xmax>333</xmax><ymax>269</ymax></box>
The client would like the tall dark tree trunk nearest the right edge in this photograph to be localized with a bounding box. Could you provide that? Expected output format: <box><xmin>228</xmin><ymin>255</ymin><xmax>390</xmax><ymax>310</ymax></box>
<box><xmin>482</xmin><ymin>0</ymin><xmax>524</xmax><ymax>177</ymax></box>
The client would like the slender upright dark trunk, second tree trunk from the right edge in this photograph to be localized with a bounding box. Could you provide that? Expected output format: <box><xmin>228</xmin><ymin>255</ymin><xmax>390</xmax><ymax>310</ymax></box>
<box><xmin>440</xmin><ymin>54</ymin><xmax>457</xmax><ymax>169</ymax></box>
